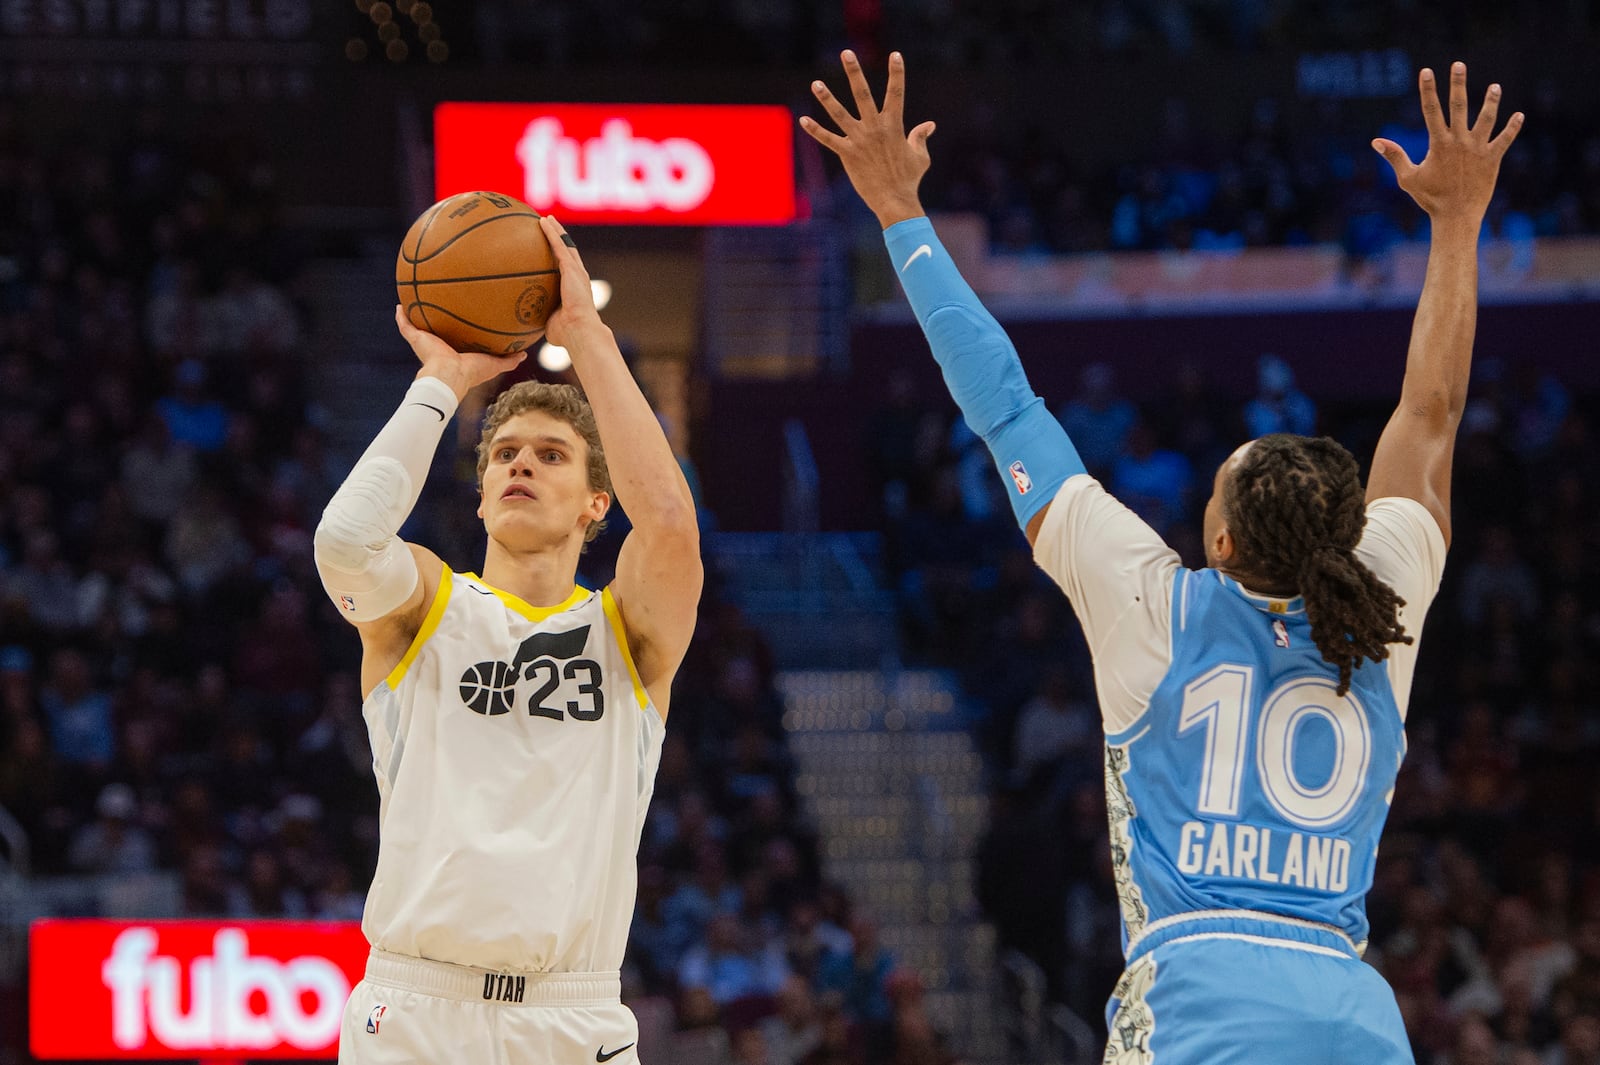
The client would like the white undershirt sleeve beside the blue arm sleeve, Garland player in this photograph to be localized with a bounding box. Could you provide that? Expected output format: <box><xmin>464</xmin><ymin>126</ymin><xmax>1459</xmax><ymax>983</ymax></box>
<box><xmin>1034</xmin><ymin>473</ymin><xmax>1181</xmax><ymax>732</ymax></box>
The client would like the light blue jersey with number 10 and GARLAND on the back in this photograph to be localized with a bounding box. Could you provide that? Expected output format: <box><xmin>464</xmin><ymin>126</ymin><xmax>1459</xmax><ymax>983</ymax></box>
<box><xmin>1106</xmin><ymin>569</ymin><xmax>1405</xmax><ymax>948</ymax></box>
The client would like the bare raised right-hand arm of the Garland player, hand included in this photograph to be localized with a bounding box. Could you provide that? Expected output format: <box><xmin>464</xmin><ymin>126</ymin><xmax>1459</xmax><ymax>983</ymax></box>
<box><xmin>1366</xmin><ymin>62</ymin><xmax>1523</xmax><ymax>544</ymax></box>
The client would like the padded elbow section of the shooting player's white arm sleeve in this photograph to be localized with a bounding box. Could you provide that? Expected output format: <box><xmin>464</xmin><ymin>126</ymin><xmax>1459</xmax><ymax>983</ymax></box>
<box><xmin>315</xmin><ymin>457</ymin><xmax>419</xmax><ymax>622</ymax></box>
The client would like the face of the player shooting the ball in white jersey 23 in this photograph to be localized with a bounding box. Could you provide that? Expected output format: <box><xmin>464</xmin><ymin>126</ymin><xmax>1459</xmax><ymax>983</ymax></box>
<box><xmin>478</xmin><ymin>411</ymin><xmax>611</xmax><ymax>550</ymax></box>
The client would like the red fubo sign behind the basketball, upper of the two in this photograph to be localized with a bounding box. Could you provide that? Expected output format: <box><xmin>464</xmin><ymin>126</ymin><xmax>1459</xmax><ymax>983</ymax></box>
<box><xmin>434</xmin><ymin>104</ymin><xmax>795</xmax><ymax>225</ymax></box>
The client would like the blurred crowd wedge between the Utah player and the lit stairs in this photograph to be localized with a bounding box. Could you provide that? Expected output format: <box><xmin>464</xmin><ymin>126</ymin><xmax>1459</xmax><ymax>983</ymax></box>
<box><xmin>624</xmin><ymin>590</ymin><xmax>955</xmax><ymax>1065</ymax></box>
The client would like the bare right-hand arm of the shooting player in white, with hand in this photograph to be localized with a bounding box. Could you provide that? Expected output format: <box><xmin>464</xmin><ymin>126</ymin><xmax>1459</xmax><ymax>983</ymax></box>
<box><xmin>539</xmin><ymin>214</ymin><xmax>704</xmax><ymax>716</ymax></box>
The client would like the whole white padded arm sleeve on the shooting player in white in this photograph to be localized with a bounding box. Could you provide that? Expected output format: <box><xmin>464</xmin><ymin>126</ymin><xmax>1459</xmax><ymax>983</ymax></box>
<box><xmin>312</xmin><ymin>377</ymin><xmax>456</xmax><ymax>622</ymax></box>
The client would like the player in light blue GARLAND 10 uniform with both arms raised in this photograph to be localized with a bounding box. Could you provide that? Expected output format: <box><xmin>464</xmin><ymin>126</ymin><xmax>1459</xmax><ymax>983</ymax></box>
<box><xmin>800</xmin><ymin>51</ymin><xmax>1522</xmax><ymax>1065</ymax></box>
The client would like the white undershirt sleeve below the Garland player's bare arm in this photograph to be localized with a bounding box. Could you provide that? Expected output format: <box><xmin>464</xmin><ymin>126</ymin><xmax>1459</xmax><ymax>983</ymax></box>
<box><xmin>1355</xmin><ymin>496</ymin><xmax>1445</xmax><ymax>721</ymax></box>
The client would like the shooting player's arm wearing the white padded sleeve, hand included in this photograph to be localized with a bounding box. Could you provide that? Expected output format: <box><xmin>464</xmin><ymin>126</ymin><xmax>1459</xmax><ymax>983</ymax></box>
<box><xmin>312</xmin><ymin>307</ymin><xmax>526</xmax><ymax>694</ymax></box>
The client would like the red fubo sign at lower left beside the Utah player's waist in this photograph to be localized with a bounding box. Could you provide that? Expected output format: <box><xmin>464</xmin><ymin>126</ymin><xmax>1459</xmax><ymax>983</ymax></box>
<box><xmin>29</xmin><ymin>921</ymin><xmax>366</xmax><ymax>1060</ymax></box>
